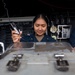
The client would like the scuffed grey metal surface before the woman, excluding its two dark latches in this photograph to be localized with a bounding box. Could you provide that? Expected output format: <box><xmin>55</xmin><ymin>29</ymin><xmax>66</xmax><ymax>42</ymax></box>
<box><xmin>0</xmin><ymin>42</ymin><xmax>75</xmax><ymax>75</ymax></box>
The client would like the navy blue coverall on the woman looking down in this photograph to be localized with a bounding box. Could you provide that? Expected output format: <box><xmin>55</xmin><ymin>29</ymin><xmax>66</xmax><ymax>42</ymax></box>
<box><xmin>20</xmin><ymin>34</ymin><xmax>56</xmax><ymax>42</ymax></box>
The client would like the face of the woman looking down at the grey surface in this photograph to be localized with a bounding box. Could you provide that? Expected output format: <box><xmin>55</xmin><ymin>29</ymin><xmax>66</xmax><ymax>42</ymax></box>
<box><xmin>34</xmin><ymin>18</ymin><xmax>47</xmax><ymax>36</ymax></box>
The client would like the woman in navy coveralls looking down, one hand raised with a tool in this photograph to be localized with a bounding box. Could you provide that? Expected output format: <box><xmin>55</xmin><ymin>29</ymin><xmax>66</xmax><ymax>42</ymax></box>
<box><xmin>12</xmin><ymin>14</ymin><xmax>55</xmax><ymax>42</ymax></box>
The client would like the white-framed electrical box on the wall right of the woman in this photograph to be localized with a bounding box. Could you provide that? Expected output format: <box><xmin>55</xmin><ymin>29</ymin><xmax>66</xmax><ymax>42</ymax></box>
<box><xmin>57</xmin><ymin>25</ymin><xmax>71</xmax><ymax>39</ymax></box>
